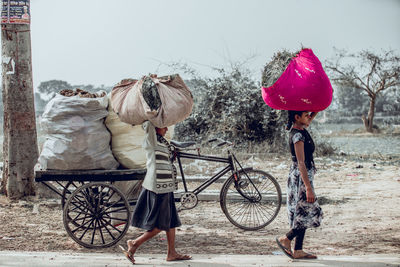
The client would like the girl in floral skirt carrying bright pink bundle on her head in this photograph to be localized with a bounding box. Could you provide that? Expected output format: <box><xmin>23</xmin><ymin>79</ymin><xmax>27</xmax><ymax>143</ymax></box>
<box><xmin>262</xmin><ymin>49</ymin><xmax>332</xmax><ymax>259</ymax></box>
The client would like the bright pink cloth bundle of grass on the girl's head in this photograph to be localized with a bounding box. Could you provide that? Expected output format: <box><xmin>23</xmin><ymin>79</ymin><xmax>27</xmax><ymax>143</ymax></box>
<box><xmin>262</xmin><ymin>48</ymin><xmax>333</xmax><ymax>111</ymax></box>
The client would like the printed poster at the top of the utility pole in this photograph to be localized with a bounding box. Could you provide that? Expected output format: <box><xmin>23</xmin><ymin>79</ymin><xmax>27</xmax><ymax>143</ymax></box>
<box><xmin>1</xmin><ymin>0</ymin><xmax>31</xmax><ymax>24</ymax></box>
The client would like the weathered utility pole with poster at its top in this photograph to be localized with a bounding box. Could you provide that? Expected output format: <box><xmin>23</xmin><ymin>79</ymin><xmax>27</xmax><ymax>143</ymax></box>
<box><xmin>0</xmin><ymin>0</ymin><xmax>38</xmax><ymax>199</ymax></box>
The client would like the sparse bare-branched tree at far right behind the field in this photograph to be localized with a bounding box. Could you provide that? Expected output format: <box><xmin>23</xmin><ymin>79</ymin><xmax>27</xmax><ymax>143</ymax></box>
<box><xmin>326</xmin><ymin>50</ymin><xmax>400</xmax><ymax>132</ymax></box>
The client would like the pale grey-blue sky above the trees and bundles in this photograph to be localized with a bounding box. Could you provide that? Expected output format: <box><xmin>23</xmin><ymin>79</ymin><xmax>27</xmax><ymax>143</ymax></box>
<box><xmin>9</xmin><ymin>0</ymin><xmax>400</xmax><ymax>88</ymax></box>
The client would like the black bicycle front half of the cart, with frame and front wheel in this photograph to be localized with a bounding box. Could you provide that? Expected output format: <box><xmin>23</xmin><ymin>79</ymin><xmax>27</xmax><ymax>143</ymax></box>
<box><xmin>170</xmin><ymin>138</ymin><xmax>282</xmax><ymax>230</ymax></box>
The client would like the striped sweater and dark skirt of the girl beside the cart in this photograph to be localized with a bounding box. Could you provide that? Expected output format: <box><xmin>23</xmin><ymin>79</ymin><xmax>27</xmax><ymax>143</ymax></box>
<box><xmin>132</xmin><ymin>122</ymin><xmax>181</xmax><ymax>231</ymax></box>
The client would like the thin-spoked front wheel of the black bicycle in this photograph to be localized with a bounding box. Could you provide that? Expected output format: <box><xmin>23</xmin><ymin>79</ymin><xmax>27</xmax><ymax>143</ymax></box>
<box><xmin>220</xmin><ymin>170</ymin><xmax>282</xmax><ymax>230</ymax></box>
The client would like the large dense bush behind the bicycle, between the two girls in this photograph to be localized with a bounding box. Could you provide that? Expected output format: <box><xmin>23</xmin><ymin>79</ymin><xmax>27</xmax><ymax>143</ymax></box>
<box><xmin>175</xmin><ymin>66</ymin><xmax>287</xmax><ymax>151</ymax></box>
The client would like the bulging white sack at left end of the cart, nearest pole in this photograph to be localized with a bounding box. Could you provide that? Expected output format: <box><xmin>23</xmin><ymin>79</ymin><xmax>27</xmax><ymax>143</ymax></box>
<box><xmin>38</xmin><ymin>91</ymin><xmax>119</xmax><ymax>170</ymax></box>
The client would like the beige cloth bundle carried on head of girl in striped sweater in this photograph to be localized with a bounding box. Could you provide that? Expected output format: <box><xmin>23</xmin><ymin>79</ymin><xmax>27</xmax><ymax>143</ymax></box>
<box><xmin>111</xmin><ymin>74</ymin><xmax>193</xmax><ymax>128</ymax></box>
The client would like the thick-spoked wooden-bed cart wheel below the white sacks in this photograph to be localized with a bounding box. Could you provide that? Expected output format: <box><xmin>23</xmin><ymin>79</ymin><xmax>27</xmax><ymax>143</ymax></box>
<box><xmin>63</xmin><ymin>183</ymin><xmax>131</xmax><ymax>248</ymax></box>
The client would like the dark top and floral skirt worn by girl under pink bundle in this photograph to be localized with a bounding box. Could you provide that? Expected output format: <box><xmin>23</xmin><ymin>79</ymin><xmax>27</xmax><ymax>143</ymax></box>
<box><xmin>286</xmin><ymin>129</ymin><xmax>323</xmax><ymax>229</ymax></box>
